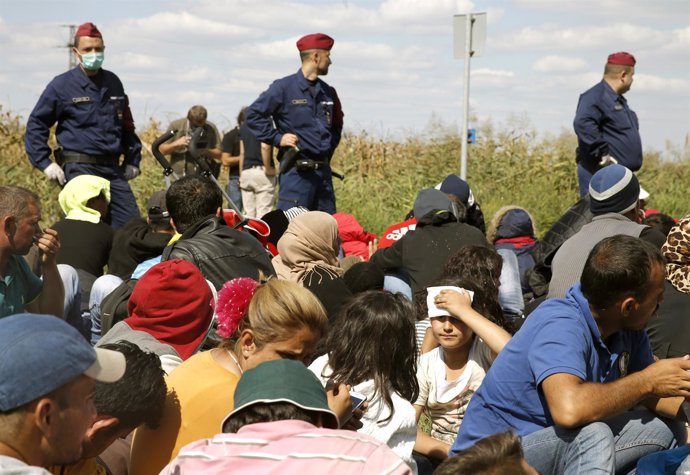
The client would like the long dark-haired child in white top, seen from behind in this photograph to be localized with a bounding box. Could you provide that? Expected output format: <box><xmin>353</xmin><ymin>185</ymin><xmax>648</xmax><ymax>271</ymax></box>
<box><xmin>309</xmin><ymin>291</ymin><xmax>419</xmax><ymax>470</ymax></box>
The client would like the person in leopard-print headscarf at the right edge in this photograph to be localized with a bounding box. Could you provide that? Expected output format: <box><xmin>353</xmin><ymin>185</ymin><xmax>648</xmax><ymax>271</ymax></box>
<box><xmin>647</xmin><ymin>215</ymin><xmax>690</xmax><ymax>358</ymax></box>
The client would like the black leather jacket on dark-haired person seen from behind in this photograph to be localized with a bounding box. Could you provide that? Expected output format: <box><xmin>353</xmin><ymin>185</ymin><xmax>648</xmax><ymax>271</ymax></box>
<box><xmin>162</xmin><ymin>216</ymin><xmax>275</xmax><ymax>290</ymax></box>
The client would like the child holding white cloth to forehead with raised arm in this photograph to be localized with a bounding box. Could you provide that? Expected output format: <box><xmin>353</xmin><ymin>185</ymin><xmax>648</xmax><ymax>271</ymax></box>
<box><xmin>414</xmin><ymin>278</ymin><xmax>510</xmax><ymax>473</ymax></box>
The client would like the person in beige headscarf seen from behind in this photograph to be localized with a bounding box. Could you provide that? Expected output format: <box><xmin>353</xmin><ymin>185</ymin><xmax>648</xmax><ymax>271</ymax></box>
<box><xmin>273</xmin><ymin>211</ymin><xmax>352</xmax><ymax>319</ymax></box>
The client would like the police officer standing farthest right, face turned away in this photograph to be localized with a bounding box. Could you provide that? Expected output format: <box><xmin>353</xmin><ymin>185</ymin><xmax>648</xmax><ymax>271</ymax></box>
<box><xmin>573</xmin><ymin>52</ymin><xmax>642</xmax><ymax>196</ymax></box>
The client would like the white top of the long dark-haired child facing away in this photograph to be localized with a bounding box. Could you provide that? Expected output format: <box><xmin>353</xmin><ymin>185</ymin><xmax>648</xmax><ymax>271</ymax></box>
<box><xmin>309</xmin><ymin>355</ymin><xmax>417</xmax><ymax>473</ymax></box>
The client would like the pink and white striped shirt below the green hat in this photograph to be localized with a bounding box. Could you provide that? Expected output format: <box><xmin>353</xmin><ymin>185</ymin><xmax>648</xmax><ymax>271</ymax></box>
<box><xmin>161</xmin><ymin>420</ymin><xmax>412</xmax><ymax>475</ymax></box>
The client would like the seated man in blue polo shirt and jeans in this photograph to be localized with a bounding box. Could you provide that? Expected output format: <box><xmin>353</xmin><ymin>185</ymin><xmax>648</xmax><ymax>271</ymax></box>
<box><xmin>451</xmin><ymin>235</ymin><xmax>690</xmax><ymax>475</ymax></box>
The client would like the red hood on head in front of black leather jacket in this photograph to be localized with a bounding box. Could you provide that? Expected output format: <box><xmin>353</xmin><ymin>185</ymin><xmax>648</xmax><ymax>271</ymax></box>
<box><xmin>125</xmin><ymin>259</ymin><xmax>213</xmax><ymax>360</ymax></box>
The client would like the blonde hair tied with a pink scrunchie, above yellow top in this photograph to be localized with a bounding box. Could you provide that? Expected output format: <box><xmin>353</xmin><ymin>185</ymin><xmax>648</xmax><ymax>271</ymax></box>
<box><xmin>225</xmin><ymin>278</ymin><xmax>328</xmax><ymax>347</ymax></box>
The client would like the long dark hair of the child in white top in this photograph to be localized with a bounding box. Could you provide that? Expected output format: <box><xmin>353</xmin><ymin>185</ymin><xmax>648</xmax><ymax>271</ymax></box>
<box><xmin>324</xmin><ymin>291</ymin><xmax>419</xmax><ymax>423</ymax></box>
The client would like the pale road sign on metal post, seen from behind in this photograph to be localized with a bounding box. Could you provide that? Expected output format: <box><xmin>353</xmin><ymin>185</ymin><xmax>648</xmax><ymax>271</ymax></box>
<box><xmin>453</xmin><ymin>13</ymin><xmax>486</xmax><ymax>180</ymax></box>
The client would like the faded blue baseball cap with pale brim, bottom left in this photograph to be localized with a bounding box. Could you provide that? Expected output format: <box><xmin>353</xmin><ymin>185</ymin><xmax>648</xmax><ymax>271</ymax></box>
<box><xmin>0</xmin><ymin>313</ymin><xmax>125</xmax><ymax>412</ymax></box>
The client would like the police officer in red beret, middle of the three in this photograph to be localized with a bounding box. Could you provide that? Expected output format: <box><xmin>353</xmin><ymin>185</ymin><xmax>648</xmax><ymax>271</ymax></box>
<box><xmin>245</xmin><ymin>33</ymin><xmax>343</xmax><ymax>214</ymax></box>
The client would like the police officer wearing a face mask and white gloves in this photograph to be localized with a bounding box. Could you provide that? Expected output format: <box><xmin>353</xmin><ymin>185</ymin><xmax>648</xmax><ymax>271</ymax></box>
<box><xmin>25</xmin><ymin>23</ymin><xmax>141</xmax><ymax>229</ymax></box>
